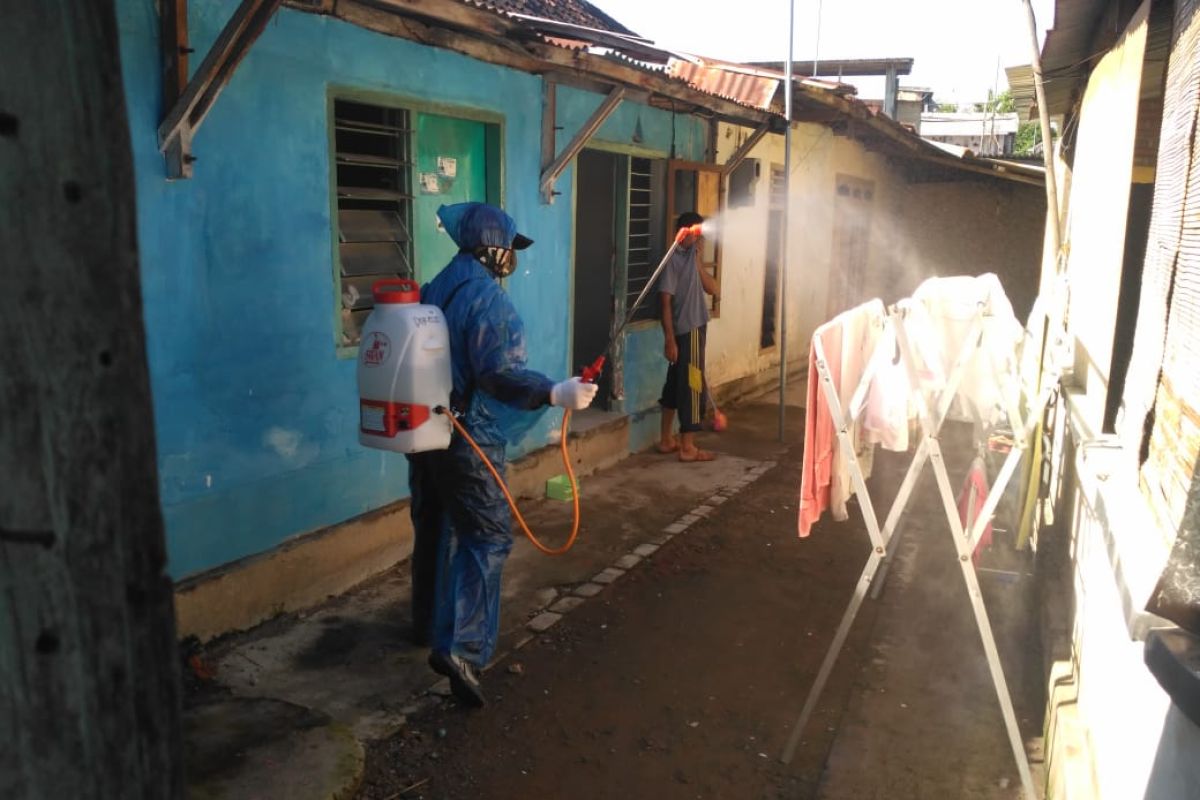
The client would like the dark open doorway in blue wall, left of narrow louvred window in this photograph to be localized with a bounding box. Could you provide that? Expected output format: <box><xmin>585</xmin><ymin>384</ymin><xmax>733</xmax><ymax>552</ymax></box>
<box><xmin>571</xmin><ymin>150</ymin><xmax>622</xmax><ymax>411</ymax></box>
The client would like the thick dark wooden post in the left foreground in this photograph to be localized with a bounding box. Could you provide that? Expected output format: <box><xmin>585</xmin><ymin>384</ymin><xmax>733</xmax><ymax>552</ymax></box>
<box><xmin>0</xmin><ymin>0</ymin><xmax>182</xmax><ymax>800</ymax></box>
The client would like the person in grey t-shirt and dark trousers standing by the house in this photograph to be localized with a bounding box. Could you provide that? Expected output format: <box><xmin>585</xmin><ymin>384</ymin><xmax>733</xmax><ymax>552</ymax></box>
<box><xmin>658</xmin><ymin>211</ymin><xmax>718</xmax><ymax>462</ymax></box>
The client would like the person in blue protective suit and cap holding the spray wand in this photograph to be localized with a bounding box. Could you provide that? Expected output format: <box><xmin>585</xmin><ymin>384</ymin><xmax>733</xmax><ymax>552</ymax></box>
<box><xmin>408</xmin><ymin>203</ymin><xmax>596</xmax><ymax>706</ymax></box>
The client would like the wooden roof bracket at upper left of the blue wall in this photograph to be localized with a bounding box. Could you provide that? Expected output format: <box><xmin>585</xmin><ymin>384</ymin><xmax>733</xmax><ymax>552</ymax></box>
<box><xmin>158</xmin><ymin>0</ymin><xmax>282</xmax><ymax>180</ymax></box>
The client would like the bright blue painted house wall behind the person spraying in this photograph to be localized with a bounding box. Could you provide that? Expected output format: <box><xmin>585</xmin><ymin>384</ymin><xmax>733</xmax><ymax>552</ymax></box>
<box><xmin>118</xmin><ymin>0</ymin><xmax>704</xmax><ymax>577</ymax></box>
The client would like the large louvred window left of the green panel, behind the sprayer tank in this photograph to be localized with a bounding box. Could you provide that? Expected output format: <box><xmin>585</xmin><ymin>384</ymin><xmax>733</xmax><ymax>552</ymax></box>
<box><xmin>334</xmin><ymin>100</ymin><xmax>413</xmax><ymax>347</ymax></box>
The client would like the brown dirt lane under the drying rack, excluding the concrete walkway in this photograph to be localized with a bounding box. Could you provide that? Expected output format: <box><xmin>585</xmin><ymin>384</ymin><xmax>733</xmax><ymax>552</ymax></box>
<box><xmin>358</xmin><ymin>401</ymin><xmax>1040</xmax><ymax>800</ymax></box>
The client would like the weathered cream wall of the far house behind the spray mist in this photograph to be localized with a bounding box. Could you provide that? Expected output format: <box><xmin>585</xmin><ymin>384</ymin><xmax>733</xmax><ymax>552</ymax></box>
<box><xmin>707</xmin><ymin>125</ymin><xmax>1045</xmax><ymax>393</ymax></box>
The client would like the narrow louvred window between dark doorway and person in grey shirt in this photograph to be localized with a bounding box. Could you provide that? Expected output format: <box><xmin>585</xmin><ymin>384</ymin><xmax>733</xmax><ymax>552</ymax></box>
<box><xmin>625</xmin><ymin>158</ymin><xmax>667</xmax><ymax>320</ymax></box>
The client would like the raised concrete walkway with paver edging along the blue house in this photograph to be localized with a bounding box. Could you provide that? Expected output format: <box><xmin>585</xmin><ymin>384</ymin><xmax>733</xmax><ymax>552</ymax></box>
<box><xmin>184</xmin><ymin>388</ymin><xmax>798</xmax><ymax>800</ymax></box>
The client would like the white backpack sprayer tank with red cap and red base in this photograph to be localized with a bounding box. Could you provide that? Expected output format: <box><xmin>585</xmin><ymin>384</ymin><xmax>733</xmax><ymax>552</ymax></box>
<box><xmin>359</xmin><ymin>279</ymin><xmax>454</xmax><ymax>453</ymax></box>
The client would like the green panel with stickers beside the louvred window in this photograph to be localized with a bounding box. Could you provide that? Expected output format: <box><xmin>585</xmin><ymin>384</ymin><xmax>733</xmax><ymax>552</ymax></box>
<box><xmin>413</xmin><ymin>114</ymin><xmax>489</xmax><ymax>283</ymax></box>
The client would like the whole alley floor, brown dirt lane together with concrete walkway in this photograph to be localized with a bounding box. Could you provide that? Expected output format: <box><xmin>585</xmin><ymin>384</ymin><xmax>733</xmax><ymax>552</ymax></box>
<box><xmin>182</xmin><ymin>383</ymin><xmax>1040</xmax><ymax>800</ymax></box>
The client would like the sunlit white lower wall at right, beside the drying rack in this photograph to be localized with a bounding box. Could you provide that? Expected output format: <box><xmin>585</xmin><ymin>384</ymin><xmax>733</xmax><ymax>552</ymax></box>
<box><xmin>1038</xmin><ymin>400</ymin><xmax>1200</xmax><ymax>800</ymax></box>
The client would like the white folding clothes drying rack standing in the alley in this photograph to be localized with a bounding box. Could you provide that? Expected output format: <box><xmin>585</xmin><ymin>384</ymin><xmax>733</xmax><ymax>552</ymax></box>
<box><xmin>782</xmin><ymin>302</ymin><xmax>1057</xmax><ymax>800</ymax></box>
